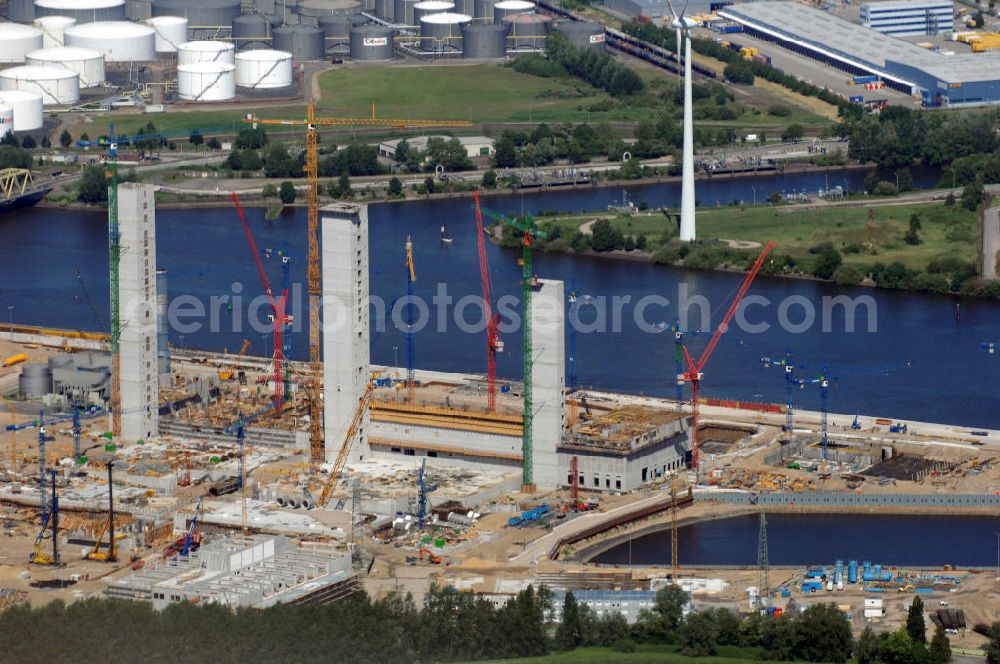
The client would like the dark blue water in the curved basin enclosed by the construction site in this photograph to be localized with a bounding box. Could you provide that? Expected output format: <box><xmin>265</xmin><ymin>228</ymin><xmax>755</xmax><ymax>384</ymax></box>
<box><xmin>592</xmin><ymin>514</ymin><xmax>1000</xmax><ymax>567</ymax></box>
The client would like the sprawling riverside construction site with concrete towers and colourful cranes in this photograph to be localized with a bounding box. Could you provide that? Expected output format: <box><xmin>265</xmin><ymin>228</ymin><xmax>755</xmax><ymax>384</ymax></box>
<box><xmin>0</xmin><ymin>119</ymin><xmax>1000</xmax><ymax>644</ymax></box>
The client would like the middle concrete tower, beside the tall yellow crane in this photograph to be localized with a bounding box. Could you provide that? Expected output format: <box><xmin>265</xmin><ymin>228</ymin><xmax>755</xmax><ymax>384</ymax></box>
<box><xmin>319</xmin><ymin>203</ymin><xmax>371</xmax><ymax>461</ymax></box>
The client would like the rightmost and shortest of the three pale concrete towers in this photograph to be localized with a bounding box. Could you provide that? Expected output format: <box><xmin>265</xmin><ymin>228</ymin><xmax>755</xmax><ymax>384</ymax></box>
<box><xmin>531</xmin><ymin>279</ymin><xmax>566</xmax><ymax>490</ymax></box>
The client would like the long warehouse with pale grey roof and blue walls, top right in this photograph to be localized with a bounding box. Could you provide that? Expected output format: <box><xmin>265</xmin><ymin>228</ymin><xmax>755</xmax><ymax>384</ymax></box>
<box><xmin>719</xmin><ymin>0</ymin><xmax>1000</xmax><ymax>107</ymax></box>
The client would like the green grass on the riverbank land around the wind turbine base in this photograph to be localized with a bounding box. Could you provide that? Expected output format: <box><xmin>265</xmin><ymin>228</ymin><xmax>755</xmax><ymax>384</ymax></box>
<box><xmin>540</xmin><ymin>203</ymin><xmax>976</xmax><ymax>270</ymax></box>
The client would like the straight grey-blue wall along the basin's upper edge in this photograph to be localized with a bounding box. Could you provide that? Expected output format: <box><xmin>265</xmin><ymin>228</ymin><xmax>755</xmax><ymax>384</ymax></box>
<box><xmin>694</xmin><ymin>491</ymin><xmax>1000</xmax><ymax>508</ymax></box>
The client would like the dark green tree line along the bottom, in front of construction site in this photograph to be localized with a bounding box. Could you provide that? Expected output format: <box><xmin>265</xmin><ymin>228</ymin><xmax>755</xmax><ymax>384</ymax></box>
<box><xmin>0</xmin><ymin>585</ymin><xmax>984</xmax><ymax>664</ymax></box>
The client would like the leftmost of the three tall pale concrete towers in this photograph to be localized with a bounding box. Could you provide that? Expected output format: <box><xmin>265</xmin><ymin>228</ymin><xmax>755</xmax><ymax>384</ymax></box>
<box><xmin>118</xmin><ymin>183</ymin><xmax>160</xmax><ymax>440</ymax></box>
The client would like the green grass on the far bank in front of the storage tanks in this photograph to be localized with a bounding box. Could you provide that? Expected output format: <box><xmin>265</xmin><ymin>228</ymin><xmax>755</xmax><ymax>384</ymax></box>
<box><xmin>92</xmin><ymin>64</ymin><xmax>827</xmax><ymax>138</ymax></box>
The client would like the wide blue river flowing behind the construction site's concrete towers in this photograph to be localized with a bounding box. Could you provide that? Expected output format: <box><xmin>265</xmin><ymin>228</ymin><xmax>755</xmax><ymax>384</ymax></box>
<box><xmin>0</xmin><ymin>163</ymin><xmax>1000</xmax><ymax>428</ymax></box>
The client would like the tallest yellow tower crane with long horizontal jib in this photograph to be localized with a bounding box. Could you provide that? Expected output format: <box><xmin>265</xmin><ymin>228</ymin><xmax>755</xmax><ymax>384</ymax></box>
<box><xmin>243</xmin><ymin>102</ymin><xmax>472</xmax><ymax>463</ymax></box>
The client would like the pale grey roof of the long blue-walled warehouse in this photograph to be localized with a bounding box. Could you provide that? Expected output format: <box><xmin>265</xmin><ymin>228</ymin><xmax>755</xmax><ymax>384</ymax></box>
<box><xmin>719</xmin><ymin>0</ymin><xmax>1000</xmax><ymax>85</ymax></box>
